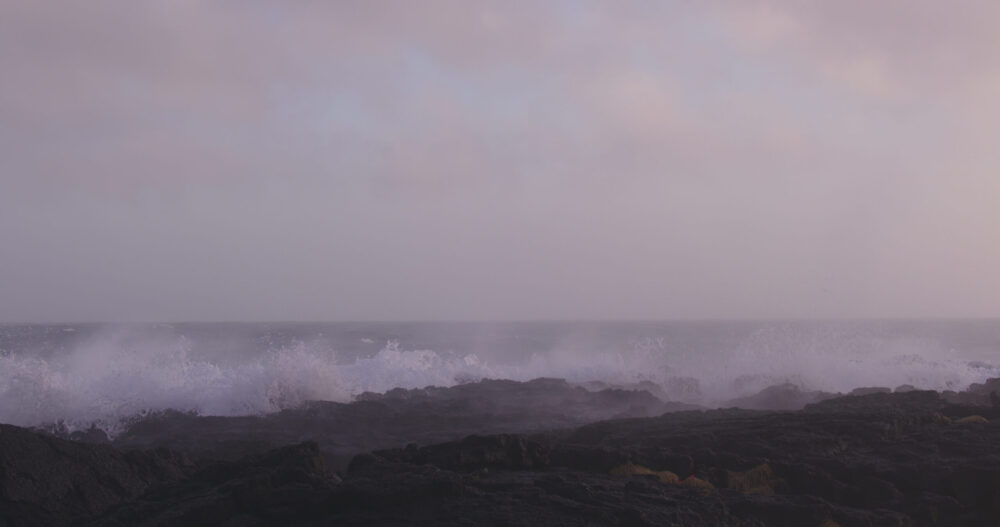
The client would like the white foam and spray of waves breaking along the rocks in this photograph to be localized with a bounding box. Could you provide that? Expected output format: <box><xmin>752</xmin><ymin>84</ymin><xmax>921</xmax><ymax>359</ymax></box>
<box><xmin>0</xmin><ymin>328</ymin><xmax>1000</xmax><ymax>432</ymax></box>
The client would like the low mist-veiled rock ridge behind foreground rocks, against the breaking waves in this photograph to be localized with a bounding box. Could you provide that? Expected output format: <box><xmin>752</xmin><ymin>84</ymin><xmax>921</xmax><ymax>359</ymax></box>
<box><xmin>114</xmin><ymin>379</ymin><xmax>695</xmax><ymax>468</ymax></box>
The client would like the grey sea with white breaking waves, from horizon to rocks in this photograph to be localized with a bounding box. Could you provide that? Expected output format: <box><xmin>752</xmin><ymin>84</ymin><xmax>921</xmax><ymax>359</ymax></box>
<box><xmin>0</xmin><ymin>320</ymin><xmax>1000</xmax><ymax>431</ymax></box>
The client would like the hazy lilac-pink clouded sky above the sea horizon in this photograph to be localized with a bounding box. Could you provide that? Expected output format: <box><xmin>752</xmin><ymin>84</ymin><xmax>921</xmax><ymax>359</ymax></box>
<box><xmin>0</xmin><ymin>0</ymin><xmax>1000</xmax><ymax>322</ymax></box>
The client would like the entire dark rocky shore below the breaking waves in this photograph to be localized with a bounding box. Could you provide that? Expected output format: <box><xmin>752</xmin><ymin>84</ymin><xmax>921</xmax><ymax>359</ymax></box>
<box><xmin>0</xmin><ymin>379</ymin><xmax>1000</xmax><ymax>527</ymax></box>
